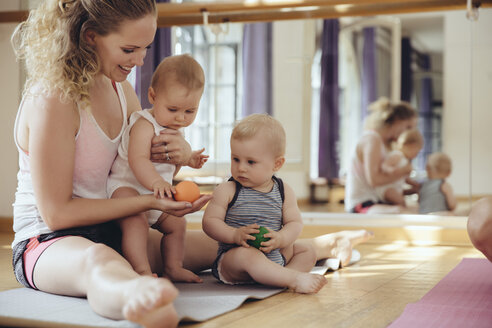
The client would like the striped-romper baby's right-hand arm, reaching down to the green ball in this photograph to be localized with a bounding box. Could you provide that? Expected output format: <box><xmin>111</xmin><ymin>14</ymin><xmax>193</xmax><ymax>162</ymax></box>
<box><xmin>260</xmin><ymin>183</ymin><xmax>303</xmax><ymax>253</ymax></box>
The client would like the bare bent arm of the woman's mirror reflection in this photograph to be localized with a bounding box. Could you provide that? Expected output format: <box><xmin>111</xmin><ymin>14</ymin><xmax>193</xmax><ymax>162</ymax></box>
<box><xmin>357</xmin><ymin>136</ymin><xmax>412</xmax><ymax>187</ymax></box>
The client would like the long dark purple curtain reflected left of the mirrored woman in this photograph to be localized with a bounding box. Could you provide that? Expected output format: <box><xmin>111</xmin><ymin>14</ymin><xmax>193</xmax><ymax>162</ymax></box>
<box><xmin>318</xmin><ymin>19</ymin><xmax>340</xmax><ymax>179</ymax></box>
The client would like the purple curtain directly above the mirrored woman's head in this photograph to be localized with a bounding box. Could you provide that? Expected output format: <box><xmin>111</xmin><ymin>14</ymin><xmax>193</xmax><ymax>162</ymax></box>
<box><xmin>361</xmin><ymin>27</ymin><xmax>378</xmax><ymax>119</ymax></box>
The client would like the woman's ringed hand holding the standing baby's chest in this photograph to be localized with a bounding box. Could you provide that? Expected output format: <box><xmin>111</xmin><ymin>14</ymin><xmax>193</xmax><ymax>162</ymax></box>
<box><xmin>150</xmin><ymin>129</ymin><xmax>192</xmax><ymax>165</ymax></box>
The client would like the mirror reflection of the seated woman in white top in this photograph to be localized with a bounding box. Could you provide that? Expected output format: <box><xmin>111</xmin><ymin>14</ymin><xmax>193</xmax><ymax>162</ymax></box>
<box><xmin>345</xmin><ymin>98</ymin><xmax>417</xmax><ymax>214</ymax></box>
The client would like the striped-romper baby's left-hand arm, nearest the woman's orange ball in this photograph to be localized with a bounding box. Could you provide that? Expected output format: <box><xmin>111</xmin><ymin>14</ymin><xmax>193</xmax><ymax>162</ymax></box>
<box><xmin>202</xmin><ymin>181</ymin><xmax>259</xmax><ymax>247</ymax></box>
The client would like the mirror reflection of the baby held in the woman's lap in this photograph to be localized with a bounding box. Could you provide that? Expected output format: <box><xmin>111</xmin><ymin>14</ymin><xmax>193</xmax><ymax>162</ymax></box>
<box><xmin>376</xmin><ymin>129</ymin><xmax>424</xmax><ymax>206</ymax></box>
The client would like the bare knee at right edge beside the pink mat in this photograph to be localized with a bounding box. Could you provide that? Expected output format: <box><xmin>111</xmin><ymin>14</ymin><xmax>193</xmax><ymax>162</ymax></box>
<box><xmin>467</xmin><ymin>197</ymin><xmax>492</xmax><ymax>262</ymax></box>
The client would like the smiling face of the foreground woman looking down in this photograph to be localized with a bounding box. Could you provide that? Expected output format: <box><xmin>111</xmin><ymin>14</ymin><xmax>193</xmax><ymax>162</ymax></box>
<box><xmin>87</xmin><ymin>15</ymin><xmax>157</xmax><ymax>82</ymax></box>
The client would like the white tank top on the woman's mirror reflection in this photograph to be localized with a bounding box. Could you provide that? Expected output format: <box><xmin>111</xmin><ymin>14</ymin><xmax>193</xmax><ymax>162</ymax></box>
<box><xmin>345</xmin><ymin>130</ymin><xmax>386</xmax><ymax>212</ymax></box>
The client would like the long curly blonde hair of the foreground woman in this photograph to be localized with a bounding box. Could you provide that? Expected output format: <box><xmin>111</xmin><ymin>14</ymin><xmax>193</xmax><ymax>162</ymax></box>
<box><xmin>11</xmin><ymin>0</ymin><xmax>156</xmax><ymax>107</ymax></box>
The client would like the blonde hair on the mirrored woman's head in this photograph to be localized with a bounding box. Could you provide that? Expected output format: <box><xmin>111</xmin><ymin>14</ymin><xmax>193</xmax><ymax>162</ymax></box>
<box><xmin>365</xmin><ymin>97</ymin><xmax>417</xmax><ymax>129</ymax></box>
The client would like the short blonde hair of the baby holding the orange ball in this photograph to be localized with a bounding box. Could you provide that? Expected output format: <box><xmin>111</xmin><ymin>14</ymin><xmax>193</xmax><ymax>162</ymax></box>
<box><xmin>150</xmin><ymin>54</ymin><xmax>205</xmax><ymax>93</ymax></box>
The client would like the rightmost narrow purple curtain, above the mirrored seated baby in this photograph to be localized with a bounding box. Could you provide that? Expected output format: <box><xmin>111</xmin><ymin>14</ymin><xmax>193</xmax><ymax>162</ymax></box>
<box><xmin>418</xmin><ymin>54</ymin><xmax>433</xmax><ymax>169</ymax></box>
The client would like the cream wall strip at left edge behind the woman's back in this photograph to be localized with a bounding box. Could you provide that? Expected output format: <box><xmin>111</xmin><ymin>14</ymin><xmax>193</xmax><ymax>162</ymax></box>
<box><xmin>0</xmin><ymin>0</ymin><xmax>20</xmax><ymax>218</ymax></box>
